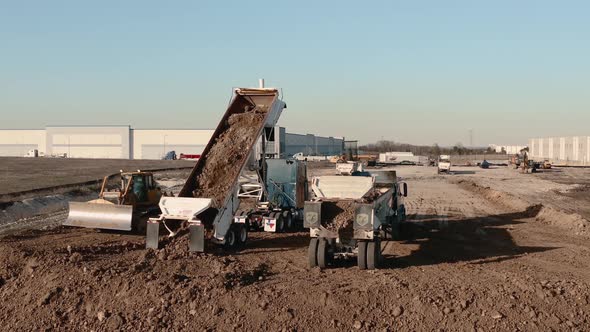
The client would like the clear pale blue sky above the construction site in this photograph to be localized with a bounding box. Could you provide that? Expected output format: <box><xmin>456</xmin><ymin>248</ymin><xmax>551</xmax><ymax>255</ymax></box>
<box><xmin>0</xmin><ymin>0</ymin><xmax>590</xmax><ymax>145</ymax></box>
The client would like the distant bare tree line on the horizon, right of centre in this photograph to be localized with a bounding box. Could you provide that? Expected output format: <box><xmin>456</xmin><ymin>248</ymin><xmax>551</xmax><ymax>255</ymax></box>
<box><xmin>359</xmin><ymin>140</ymin><xmax>505</xmax><ymax>157</ymax></box>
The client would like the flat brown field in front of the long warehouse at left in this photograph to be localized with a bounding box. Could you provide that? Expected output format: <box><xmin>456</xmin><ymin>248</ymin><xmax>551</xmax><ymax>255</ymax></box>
<box><xmin>0</xmin><ymin>157</ymin><xmax>195</xmax><ymax>196</ymax></box>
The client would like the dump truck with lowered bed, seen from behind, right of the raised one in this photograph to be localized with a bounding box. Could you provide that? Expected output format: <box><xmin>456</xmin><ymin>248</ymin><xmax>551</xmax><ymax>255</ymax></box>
<box><xmin>304</xmin><ymin>171</ymin><xmax>408</xmax><ymax>270</ymax></box>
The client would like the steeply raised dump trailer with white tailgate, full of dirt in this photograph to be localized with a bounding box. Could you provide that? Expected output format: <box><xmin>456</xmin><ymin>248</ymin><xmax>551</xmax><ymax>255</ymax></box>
<box><xmin>146</xmin><ymin>86</ymin><xmax>286</xmax><ymax>252</ymax></box>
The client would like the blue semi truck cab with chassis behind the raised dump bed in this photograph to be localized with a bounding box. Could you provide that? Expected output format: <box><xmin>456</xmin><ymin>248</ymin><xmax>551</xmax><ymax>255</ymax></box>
<box><xmin>234</xmin><ymin>159</ymin><xmax>308</xmax><ymax>233</ymax></box>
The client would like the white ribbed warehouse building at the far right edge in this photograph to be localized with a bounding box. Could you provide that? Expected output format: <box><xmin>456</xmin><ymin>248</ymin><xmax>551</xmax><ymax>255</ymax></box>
<box><xmin>529</xmin><ymin>136</ymin><xmax>590</xmax><ymax>166</ymax></box>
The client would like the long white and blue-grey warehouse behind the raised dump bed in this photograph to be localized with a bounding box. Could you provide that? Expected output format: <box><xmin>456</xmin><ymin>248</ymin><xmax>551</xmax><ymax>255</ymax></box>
<box><xmin>0</xmin><ymin>126</ymin><xmax>344</xmax><ymax>159</ymax></box>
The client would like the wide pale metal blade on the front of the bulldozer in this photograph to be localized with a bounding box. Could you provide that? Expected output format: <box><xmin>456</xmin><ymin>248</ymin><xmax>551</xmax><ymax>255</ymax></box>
<box><xmin>63</xmin><ymin>202</ymin><xmax>133</xmax><ymax>231</ymax></box>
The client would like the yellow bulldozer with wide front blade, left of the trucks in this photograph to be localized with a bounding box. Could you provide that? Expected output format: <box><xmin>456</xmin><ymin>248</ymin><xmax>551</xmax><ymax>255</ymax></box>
<box><xmin>63</xmin><ymin>170</ymin><xmax>163</xmax><ymax>233</ymax></box>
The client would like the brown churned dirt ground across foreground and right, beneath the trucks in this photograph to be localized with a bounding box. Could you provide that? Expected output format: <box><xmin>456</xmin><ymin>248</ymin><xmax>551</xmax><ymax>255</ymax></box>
<box><xmin>0</xmin><ymin>167</ymin><xmax>590</xmax><ymax>331</ymax></box>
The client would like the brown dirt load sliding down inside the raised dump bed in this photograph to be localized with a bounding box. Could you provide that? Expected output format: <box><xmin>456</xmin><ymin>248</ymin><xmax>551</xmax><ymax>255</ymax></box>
<box><xmin>193</xmin><ymin>106</ymin><xmax>269</xmax><ymax>208</ymax></box>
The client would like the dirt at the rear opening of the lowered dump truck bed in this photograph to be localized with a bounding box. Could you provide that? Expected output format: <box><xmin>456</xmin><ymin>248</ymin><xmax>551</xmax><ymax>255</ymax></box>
<box><xmin>322</xmin><ymin>201</ymin><xmax>355</xmax><ymax>238</ymax></box>
